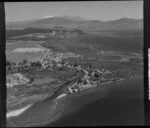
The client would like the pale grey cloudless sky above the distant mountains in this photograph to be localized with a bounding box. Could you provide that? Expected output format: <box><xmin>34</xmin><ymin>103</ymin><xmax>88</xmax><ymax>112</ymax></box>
<box><xmin>5</xmin><ymin>1</ymin><xmax>143</xmax><ymax>22</ymax></box>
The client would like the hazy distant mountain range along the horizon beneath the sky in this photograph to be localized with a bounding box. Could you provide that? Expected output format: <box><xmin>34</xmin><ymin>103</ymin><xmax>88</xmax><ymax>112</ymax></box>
<box><xmin>6</xmin><ymin>16</ymin><xmax>143</xmax><ymax>31</ymax></box>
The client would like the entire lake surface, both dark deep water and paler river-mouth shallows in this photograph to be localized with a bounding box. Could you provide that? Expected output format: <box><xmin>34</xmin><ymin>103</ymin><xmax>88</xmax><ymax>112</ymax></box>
<box><xmin>7</xmin><ymin>76</ymin><xmax>144</xmax><ymax>127</ymax></box>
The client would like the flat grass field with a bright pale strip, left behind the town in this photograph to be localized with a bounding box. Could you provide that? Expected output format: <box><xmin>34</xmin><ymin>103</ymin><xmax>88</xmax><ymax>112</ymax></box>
<box><xmin>6</xmin><ymin>41</ymin><xmax>48</xmax><ymax>63</ymax></box>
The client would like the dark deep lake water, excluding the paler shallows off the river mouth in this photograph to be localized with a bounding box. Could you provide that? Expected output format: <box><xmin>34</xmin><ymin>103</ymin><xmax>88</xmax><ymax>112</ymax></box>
<box><xmin>46</xmin><ymin>77</ymin><xmax>144</xmax><ymax>126</ymax></box>
